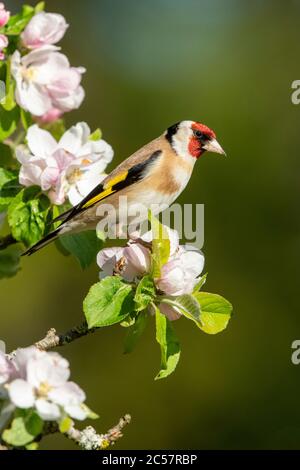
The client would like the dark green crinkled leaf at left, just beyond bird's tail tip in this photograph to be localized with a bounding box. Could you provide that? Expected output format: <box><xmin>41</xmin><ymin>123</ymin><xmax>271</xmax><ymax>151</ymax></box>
<box><xmin>8</xmin><ymin>186</ymin><xmax>50</xmax><ymax>246</ymax></box>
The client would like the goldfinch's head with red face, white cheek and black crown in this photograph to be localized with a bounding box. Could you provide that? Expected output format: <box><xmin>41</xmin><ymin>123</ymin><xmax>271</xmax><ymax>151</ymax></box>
<box><xmin>165</xmin><ymin>121</ymin><xmax>225</xmax><ymax>162</ymax></box>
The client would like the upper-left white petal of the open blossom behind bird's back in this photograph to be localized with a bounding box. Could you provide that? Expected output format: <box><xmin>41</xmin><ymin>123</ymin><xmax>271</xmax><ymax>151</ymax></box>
<box><xmin>27</xmin><ymin>124</ymin><xmax>57</xmax><ymax>158</ymax></box>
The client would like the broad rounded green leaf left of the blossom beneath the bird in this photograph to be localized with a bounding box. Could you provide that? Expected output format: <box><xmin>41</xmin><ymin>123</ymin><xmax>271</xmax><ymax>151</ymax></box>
<box><xmin>83</xmin><ymin>276</ymin><xmax>134</xmax><ymax>328</ymax></box>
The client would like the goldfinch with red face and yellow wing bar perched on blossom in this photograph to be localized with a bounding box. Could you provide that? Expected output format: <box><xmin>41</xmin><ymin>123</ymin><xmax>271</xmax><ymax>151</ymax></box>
<box><xmin>24</xmin><ymin>121</ymin><xmax>225</xmax><ymax>255</ymax></box>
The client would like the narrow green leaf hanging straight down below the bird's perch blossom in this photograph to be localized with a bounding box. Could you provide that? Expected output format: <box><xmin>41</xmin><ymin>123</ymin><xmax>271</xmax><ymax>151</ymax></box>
<box><xmin>155</xmin><ymin>306</ymin><xmax>180</xmax><ymax>380</ymax></box>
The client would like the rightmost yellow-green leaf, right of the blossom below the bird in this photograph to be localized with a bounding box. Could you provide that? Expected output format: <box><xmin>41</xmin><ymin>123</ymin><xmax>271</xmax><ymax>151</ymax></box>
<box><xmin>194</xmin><ymin>292</ymin><xmax>232</xmax><ymax>335</ymax></box>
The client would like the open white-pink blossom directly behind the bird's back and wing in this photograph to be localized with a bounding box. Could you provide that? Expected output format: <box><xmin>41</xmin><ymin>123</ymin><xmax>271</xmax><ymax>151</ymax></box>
<box><xmin>16</xmin><ymin>122</ymin><xmax>113</xmax><ymax>205</ymax></box>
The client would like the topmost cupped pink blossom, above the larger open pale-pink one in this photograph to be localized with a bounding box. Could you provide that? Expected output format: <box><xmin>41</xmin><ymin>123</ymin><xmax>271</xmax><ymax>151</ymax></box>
<box><xmin>21</xmin><ymin>11</ymin><xmax>69</xmax><ymax>49</ymax></box>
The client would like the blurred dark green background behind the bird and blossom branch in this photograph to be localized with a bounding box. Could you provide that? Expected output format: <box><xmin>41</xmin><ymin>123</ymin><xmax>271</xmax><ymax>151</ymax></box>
<box><xmin>0</xmin><ymin>0</ymin><xmax>300</xmax><ymax>449</ymax></box>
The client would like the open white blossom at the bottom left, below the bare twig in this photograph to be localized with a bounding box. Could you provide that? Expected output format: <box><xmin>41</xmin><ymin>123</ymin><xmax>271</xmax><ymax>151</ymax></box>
<box><xmin>0</xmin><ymin>346</ymin><xmax>87</xmax><ymax>421</ymax></box>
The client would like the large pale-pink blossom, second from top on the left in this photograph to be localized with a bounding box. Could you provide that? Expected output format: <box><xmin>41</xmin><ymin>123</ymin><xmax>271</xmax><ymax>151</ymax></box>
<box><xmin>11</xmin><ymin>45</ymin><xmax>85</xmax><ymax>116</ymax></box>
